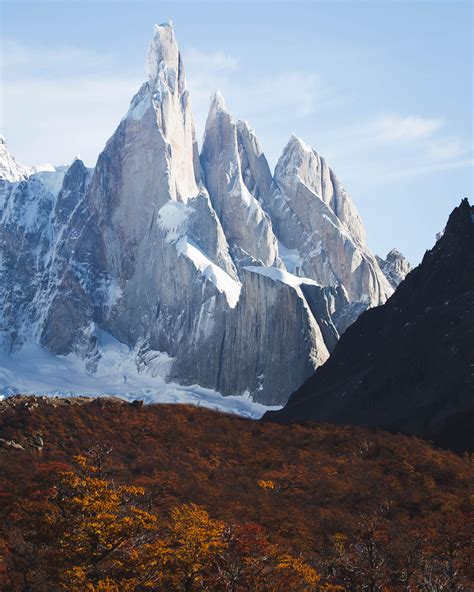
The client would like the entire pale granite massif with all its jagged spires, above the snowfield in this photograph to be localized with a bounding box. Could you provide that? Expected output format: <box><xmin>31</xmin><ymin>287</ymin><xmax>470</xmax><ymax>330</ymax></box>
<box><xmin>0</xmin><ymin>24</ymin><xmax>391</xmax><ymax>404</ymax></box>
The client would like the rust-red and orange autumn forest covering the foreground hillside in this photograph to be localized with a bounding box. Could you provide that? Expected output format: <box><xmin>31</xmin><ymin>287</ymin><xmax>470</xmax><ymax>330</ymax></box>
<box><xmin>0</xmin><ymin>397</ymin><xmax>474</xmax><ymax>592</ymax></box>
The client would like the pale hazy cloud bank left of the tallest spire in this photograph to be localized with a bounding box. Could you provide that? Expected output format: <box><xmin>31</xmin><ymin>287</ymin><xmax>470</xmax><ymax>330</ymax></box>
<box><xmin>0</xmin><ymin>41</ymin><xmax>141</xmax><ymax>165</ymax></box>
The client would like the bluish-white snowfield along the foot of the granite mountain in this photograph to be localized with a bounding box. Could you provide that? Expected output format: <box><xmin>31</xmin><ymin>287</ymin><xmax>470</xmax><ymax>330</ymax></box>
<box><xmin>0</xmin><ymin>334</ymin><xmax>280</xmax><ymax>419</ymax></box>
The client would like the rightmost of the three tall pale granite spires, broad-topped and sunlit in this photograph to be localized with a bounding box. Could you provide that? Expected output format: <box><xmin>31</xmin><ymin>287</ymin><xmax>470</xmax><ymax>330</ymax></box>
<box><xmin>263</xmin><ymin>135</ymin><xmax>392</xmax><ymax>310</ymax></box>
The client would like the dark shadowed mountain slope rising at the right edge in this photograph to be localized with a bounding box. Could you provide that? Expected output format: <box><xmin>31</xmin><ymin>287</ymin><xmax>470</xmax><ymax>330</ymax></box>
<box><xmin>265</xmin><ymin>199</ymin><xmax>474</xmax><ymax>450</ymax></box>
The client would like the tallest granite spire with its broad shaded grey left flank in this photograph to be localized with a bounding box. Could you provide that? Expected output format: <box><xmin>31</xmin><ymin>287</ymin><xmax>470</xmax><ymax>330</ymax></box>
<box><xmin>91</xmin><ymin>24</ymin><xmax>201</xmax><ymax>258</ymax></box>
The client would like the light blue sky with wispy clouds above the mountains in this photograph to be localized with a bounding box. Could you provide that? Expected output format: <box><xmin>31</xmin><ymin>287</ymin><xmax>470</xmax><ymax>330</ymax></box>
<box><xmin>0</xmin><ymin>0</ymin><xmax>474</xmax><ymax>264</ymax></box>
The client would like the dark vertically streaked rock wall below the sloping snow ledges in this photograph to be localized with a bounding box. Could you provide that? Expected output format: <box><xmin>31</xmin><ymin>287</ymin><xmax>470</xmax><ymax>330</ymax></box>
<box><xmin>170</xmin><ymin>267</ymin><xmax>329</xmax><ymax>405</ymax></box>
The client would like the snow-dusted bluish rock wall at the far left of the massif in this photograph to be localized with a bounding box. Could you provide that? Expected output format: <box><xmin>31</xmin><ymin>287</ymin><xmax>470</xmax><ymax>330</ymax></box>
<box><xmin>0</xmin><ymin>156</ymin><xmax>90</xmax><ymax>353</ymax></box>
